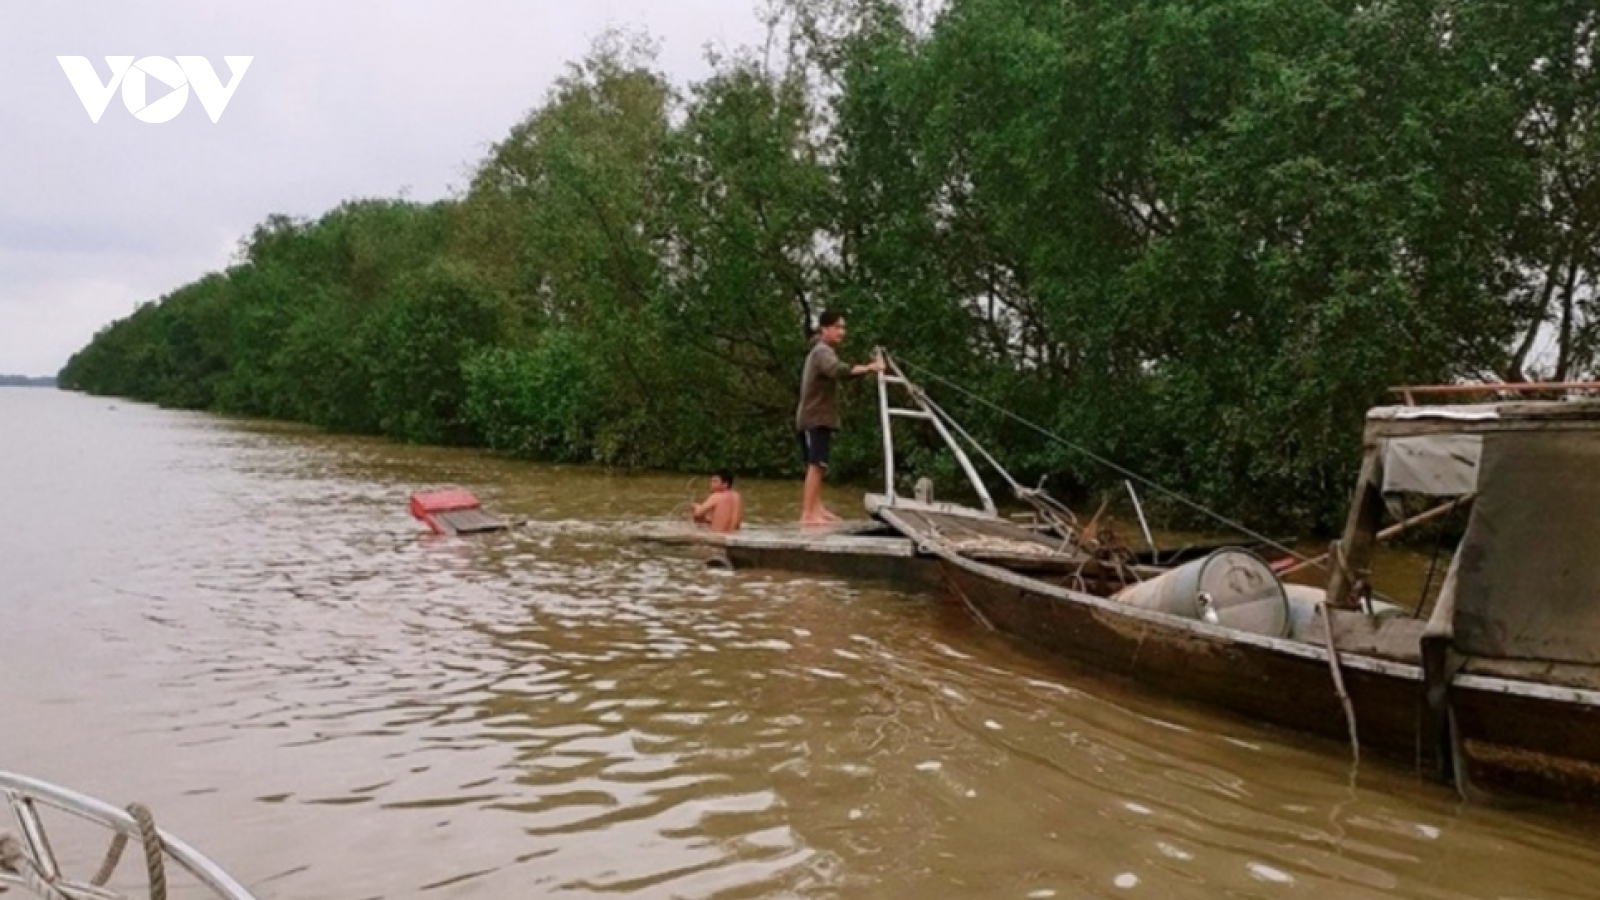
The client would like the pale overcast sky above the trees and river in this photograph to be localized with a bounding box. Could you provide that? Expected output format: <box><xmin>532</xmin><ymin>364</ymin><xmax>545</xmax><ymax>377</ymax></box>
<box><xmin>0</xmin><ymin>0</ymin><xmax>765</xmax><ymax>375</ymax></box>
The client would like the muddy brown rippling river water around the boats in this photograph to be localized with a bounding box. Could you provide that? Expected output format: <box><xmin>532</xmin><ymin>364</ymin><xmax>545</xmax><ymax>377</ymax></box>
<box><xmin>0</xmin><ymin>389</ymin><xmax>1600</xmax><ymax>900</ymax></box>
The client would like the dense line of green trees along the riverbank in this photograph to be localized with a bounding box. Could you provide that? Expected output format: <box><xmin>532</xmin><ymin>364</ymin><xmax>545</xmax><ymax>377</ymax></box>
<box><xmin>61</xmin><ymin>0</ymin><xmax>1600</xmax><ymax>528</ymax></box>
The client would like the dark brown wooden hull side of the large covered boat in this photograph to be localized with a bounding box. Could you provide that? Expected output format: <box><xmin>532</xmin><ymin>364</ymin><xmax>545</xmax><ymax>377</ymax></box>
<box><xmin>941</xmin><ymin>556</ymin><xmax>1600</xmax><ymax>802</ymax></box>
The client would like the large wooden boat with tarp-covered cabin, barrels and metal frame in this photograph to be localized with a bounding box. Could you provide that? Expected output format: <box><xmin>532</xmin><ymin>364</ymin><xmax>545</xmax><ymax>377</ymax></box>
<box><xmin>867</xmin><ymin>365</ymin><xmax>1600</xmax><ymax>802</ymax></box>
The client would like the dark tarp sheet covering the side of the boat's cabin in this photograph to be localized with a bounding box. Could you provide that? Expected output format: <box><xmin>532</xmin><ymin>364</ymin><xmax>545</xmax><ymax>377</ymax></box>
<box><xmin>1454</xmin><ymin>431</ymin><xmax>1600</xmax><ymax>663</ymax></box>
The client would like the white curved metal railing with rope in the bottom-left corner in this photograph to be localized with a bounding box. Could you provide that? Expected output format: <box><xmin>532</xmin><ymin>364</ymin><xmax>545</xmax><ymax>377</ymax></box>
<box><xmin>0</xmin><ymin>772</ymin><xmax>254</xmax><ymax>900</ymax></box>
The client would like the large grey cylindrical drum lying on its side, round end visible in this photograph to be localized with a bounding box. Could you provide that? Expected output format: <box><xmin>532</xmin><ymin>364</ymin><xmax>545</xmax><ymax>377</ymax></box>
<box><xmin>1117</xmin><ymin>549</ymin><xmax>1290</xmax><ymax>637</ymax></box>
